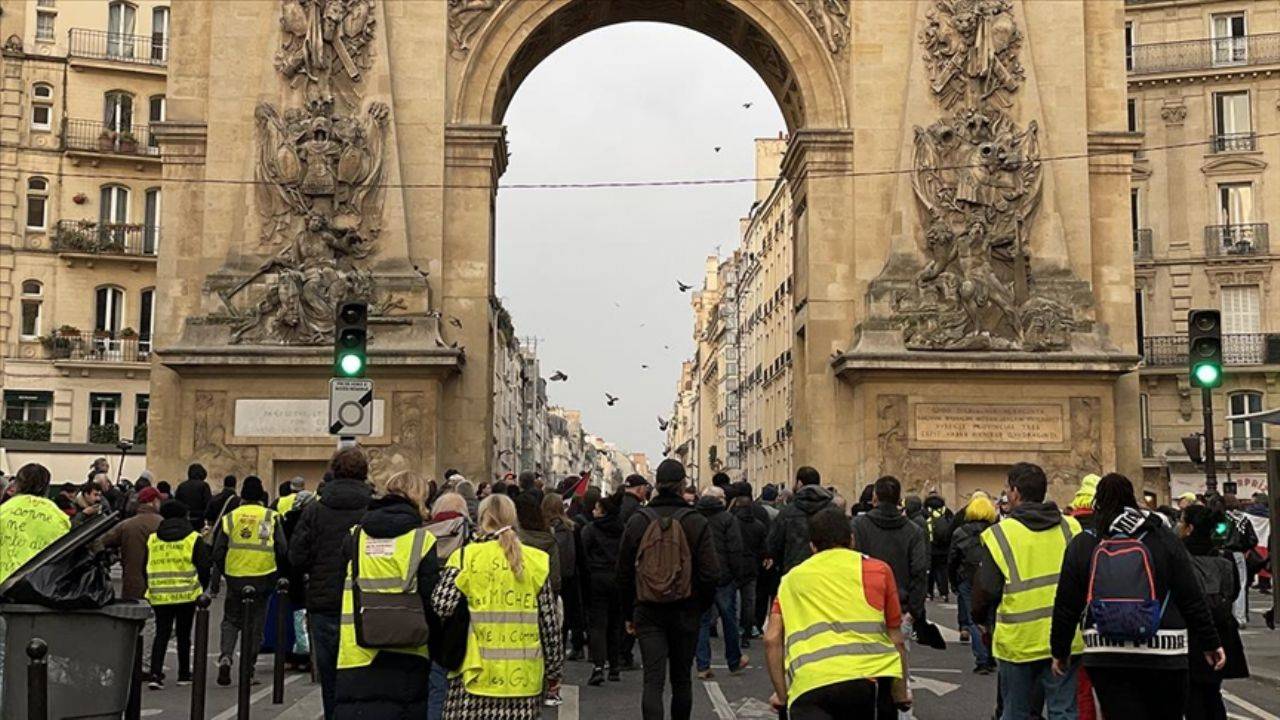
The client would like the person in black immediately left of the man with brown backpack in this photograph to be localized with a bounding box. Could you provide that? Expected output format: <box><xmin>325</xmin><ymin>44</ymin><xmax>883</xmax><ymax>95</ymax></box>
<box><xmin>582</xmin><ymin>493</ymin><xmax>626</xmax><ymax>687</ymax></box>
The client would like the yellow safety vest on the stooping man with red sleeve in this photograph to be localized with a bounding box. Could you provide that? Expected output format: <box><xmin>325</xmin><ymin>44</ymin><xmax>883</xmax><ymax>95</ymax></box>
<box><xmin>778</xmin><ymin>548</ymin><xmax>902</xmax><ymax>707</ymax></box>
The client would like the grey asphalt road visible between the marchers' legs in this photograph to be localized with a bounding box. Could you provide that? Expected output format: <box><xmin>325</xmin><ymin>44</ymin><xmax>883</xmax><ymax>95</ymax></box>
<box><xmin>143</xmin><ymin>591</ymin><xmax>1280</xmax><ymax>720</ymax></box>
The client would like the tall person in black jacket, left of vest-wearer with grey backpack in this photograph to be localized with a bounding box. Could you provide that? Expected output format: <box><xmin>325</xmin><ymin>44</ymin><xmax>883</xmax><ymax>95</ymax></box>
<box><xmin>289</xmin><ymin>447</ymin><xmax>372</xmax><ymax>720</ymax></box>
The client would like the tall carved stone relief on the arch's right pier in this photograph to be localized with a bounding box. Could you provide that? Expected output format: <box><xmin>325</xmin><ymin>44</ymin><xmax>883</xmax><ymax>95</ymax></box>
<box><xmin>892</xmin><ymin>0</ymin><xmax>1076</xmax><ymax>351</ymax></box>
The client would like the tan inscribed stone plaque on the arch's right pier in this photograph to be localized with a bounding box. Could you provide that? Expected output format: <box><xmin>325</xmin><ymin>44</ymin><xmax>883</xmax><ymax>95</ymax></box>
<box><xmin>915</xmin><ymin>402</ymin><xmax>1066</xmax><ymax>445</ymax></box>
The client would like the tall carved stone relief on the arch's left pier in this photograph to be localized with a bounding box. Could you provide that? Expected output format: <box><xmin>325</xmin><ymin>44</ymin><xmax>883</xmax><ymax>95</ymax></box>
<box><xmin>211</xmin><ymin>0</ymin><xmax>403</xmax><ymax>345</ymax></box>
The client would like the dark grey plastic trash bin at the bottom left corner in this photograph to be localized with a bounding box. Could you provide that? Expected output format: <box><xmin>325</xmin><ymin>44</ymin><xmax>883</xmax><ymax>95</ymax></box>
<box><xmin>0</xmin><ymin>602</ymin><xmax>151</xmax><ymax>720</ymax></box>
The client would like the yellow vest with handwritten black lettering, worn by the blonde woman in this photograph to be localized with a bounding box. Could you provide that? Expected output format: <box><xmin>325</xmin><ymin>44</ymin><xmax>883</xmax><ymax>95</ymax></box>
<box><xmin>447</xmin><ymin>530</ymin><xmax>550</xmax><ymax>697</ymax></box>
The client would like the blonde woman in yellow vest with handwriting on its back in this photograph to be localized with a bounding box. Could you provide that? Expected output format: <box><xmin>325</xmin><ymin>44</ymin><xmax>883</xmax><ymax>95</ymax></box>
<box><xmin>431</xmin><ymin>495</ymin><xmax>564</xmax><ymax>720</ymax></box>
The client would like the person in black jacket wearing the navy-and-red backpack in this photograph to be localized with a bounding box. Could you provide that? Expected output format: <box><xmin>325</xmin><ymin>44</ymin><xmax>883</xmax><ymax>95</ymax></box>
<box><xmin>1050</xmin><ymin>473</ymin><xmax>1226</xmax><ymax>720</ymax></box>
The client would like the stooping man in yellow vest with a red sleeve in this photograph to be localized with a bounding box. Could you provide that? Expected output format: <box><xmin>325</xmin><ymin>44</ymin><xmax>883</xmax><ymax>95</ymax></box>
<box><xmin>764</xmin><ymin>507</ymin><xmax>911</xmax><ymax>720</ymax></box>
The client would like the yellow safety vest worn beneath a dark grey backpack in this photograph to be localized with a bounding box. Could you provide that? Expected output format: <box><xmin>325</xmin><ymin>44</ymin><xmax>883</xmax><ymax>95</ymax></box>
<box><xmin>338</xmin><ymin>520</ymin><xmax>435</xmax><ymax>670</ymax></box>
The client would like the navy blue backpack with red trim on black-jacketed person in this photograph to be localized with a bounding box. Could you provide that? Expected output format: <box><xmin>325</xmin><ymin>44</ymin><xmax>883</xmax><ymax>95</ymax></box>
<box><xmin>1088</xmin><ymin>536</ymin><xmax>1169</xmax><ymax>642</ymax></box>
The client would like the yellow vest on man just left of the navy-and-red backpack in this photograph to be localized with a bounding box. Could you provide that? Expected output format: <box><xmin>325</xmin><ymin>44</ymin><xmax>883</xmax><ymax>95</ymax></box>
<box><xmin>982</xmin><ymin>516</ymin><xmax>1084</xmax><ymax>662</ymax></box>
